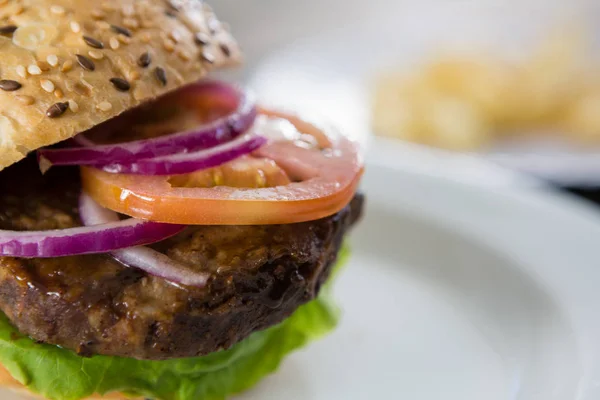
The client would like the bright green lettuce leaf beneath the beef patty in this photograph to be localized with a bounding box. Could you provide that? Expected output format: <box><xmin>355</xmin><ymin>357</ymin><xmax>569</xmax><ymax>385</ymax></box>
<box><xmin>0</xmin><ymin>249</ymin><xmax>348</xmax><ymax>400</ymax></box>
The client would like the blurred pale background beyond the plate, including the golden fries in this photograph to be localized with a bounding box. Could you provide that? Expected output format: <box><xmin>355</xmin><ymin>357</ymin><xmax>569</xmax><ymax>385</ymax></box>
<box><xmin>214</xmin><ymin>0</ymin><xmax>600</xmax><ymax>199</ymax></box>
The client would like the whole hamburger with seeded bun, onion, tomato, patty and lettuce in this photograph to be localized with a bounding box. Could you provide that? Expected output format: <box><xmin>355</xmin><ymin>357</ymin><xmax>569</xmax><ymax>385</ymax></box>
<box><xmin>0</xmin><ymin>0</ymin><xmax>363</xmax><ymax>400</ymax></box>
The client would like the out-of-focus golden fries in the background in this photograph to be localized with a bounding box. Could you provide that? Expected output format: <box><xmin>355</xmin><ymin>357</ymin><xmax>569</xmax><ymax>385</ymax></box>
<box><xmin>373</xmin><ymin>30</ymin><xmax>600</xmax><ymax>150</ymax></box>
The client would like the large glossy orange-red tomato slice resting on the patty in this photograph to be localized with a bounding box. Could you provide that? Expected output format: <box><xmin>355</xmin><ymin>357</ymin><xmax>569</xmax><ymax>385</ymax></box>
<box><xmin>81</xmin><ymin>110</ymin><xmax>363</xmax><ymax>225</ymax></box>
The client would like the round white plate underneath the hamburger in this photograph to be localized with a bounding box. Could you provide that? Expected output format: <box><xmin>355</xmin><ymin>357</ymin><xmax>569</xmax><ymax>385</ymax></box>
<box><xmin>9</xmin><ymin>143</ymin><xmax>600</xmax><ymax>400</ymax></box>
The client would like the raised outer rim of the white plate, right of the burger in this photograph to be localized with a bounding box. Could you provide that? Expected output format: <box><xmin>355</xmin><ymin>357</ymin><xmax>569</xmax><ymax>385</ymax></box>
<box><xmin>367</xmin><ymin>138</ymin><xmax>600</xmax><ymax>400</ymax></box>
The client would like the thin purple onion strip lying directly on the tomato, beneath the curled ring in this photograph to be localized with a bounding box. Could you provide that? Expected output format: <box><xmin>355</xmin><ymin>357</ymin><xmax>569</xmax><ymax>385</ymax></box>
<box><xmin>101</xmin><ymin>134</ymin><xmax>267</xmax><ymax>175</ymax></box>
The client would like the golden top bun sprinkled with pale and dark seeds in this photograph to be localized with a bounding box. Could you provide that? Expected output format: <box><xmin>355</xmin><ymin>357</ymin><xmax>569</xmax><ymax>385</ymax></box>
<box><xmin>0</xmin><ymin>0</ymin><xmax>240</xmax><ymax>170</ymax></box>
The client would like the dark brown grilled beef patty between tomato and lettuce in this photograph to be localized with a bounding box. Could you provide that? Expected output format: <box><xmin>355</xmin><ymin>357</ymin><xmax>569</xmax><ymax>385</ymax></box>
<box><xmin>0</xmin><ymin>157</ymin><xmax>362</xmax><ymax>360</ymax></box>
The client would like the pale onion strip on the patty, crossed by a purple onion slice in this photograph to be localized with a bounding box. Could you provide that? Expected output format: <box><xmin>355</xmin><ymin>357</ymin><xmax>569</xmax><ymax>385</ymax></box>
<box><xmin>79</xmin><ymin>193</ymin><xmax>210</xmax><ymax>287</ymax></box>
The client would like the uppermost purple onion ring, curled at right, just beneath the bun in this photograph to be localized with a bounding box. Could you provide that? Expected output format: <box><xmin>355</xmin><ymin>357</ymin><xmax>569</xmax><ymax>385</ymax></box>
<box><xmin>38</xmin><ymin>82</ymin><xmax>257</xmax><ymax>172</ymax></box>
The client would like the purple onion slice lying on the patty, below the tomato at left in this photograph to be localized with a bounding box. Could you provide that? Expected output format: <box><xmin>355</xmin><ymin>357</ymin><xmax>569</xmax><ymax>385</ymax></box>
<box><xmin>0</xmin><ymin>199</ymin><xmax>184</xmax><ymax>258</ymax></box>
